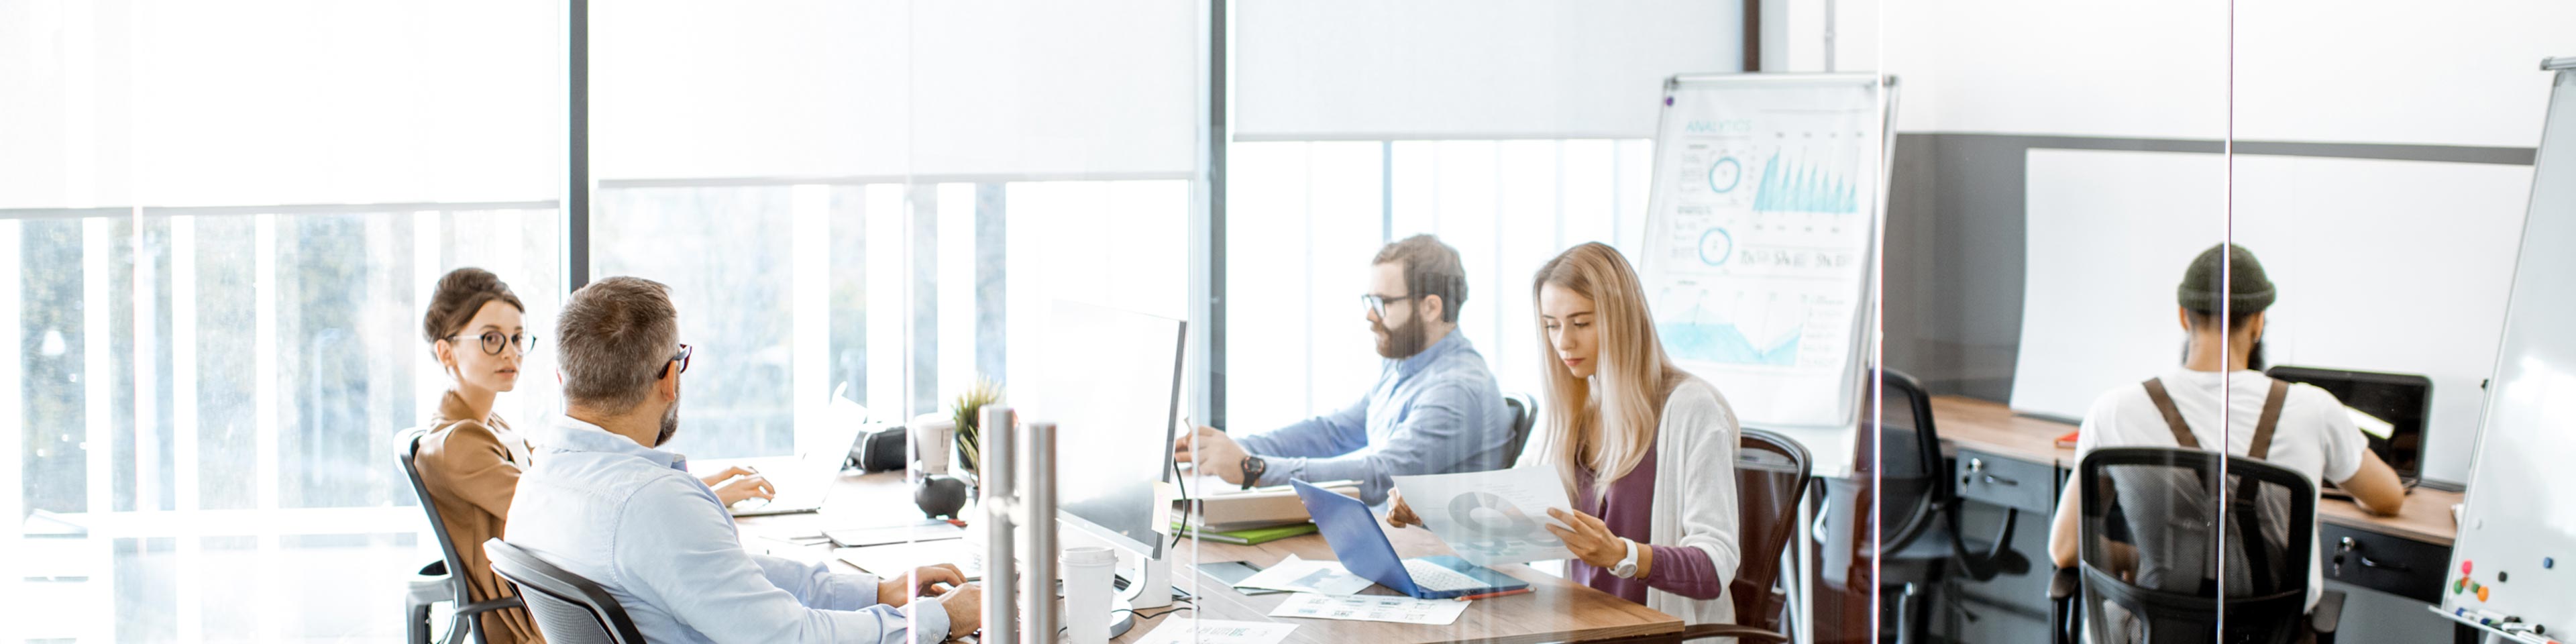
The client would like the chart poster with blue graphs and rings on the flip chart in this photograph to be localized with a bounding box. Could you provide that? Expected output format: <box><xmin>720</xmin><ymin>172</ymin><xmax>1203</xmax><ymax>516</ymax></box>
<box><xmin>1641</xmin><ymin>74</ymin><xmax>1886</xmax><ymax>427</ymax></box>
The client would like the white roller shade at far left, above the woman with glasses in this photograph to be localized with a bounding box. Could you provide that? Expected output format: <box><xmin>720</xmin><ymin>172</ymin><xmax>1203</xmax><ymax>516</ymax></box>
<box><xmin>0</xmin><ymin>0</ymin><xmax>564</xmax><ymax>209</ymax></box>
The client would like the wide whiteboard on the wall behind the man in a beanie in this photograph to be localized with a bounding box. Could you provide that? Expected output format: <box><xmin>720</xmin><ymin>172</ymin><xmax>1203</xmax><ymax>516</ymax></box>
<box><xmin>2012</xmin><ymin>150</ymin><xmax>2532</xmax><ymax>482</ymax></box>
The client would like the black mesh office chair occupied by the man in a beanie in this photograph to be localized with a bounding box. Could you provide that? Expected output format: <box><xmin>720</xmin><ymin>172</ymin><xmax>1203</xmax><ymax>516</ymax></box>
<box><xmin>2048</xmin><ymin>448</ymin><xmax>2344</xmax><ymax>644</ymax></box>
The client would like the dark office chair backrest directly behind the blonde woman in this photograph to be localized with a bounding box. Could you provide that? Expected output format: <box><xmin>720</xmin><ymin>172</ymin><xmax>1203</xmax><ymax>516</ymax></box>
<box><xmin>1726</xmin><ymin>430</ymin><xmax>1811</xmax><ymax>631</ymax></box>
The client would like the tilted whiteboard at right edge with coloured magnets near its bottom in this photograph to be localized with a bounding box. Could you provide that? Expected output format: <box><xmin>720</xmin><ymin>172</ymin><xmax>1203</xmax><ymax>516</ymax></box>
<box><xmin>2442</xmin><ymin>59</ymin><xmax>2576</xmax><ymax>639</ymax></box>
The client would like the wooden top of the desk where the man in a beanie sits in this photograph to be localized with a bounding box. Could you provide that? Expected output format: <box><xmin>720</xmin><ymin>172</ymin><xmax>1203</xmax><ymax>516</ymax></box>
<box><xmin>1932</xmin><ymin>396</ymin><xmax>2460</xmax><ymax>546</ymax></box>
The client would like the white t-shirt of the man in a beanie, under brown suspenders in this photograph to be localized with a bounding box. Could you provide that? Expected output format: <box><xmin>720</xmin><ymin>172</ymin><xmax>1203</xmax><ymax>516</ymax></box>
<box><xmin>2076</xmin><ymin>368</ymin><xmax>2370</xmax><ymax>605</ymax></box>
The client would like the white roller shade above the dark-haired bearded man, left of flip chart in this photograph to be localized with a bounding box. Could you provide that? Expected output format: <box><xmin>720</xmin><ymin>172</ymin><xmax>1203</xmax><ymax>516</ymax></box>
<box><xmin>1234</xmin><ymin>0</ymin><xmax>1744</xmax><ymax>139</ymax></box>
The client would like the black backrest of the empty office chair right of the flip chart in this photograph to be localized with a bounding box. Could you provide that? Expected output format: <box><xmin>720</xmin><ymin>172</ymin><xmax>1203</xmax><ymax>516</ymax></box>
<box><xmin>1876</xmin><ymin>368</ymin><xmax>1957</xmax><ymax>551</ymax></box>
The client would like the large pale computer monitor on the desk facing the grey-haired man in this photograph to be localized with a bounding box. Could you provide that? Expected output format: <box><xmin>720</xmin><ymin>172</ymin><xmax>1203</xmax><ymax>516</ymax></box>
<box><xmin>1015</xmin><ymin>301</ymin><xmax>1185</xmax><ymax>559</ymax></box>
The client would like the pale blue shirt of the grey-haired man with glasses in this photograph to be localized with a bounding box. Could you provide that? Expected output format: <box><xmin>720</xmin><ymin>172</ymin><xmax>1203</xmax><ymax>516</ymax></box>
<box><xmin>502</xmin><ymin>417</ymin><xmax>948</xmax><ymax>644</ymax></box>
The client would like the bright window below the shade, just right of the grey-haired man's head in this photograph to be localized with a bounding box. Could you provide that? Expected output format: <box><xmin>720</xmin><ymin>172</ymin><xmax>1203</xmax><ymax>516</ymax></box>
<box><xmin>592</xmin><ymin>180</ymin><xmax>1190</xmax><ymax>459</ymax></box>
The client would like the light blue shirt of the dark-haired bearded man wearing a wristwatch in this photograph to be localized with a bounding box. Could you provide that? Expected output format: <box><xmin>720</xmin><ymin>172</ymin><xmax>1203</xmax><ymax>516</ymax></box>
<box><xmin>1239</xmin><ymin>330</ymin><xmax>1512</xmax><ymax>505</ymax></box>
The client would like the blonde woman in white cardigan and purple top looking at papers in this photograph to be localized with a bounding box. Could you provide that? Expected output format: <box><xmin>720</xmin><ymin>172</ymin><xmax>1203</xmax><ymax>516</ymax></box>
<box><xmin>1389</xmin><ymin>245</ymin><xmax>1741</xmax><ymax>623</ymax></box>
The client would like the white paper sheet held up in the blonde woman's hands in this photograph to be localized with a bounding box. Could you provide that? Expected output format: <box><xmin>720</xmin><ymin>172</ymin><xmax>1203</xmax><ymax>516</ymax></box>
<box><xmin>1393</xmin><ymin>466</ymin><xmax>1574</xmax><ymax>567</ymax></box>
